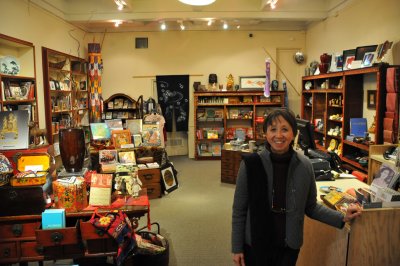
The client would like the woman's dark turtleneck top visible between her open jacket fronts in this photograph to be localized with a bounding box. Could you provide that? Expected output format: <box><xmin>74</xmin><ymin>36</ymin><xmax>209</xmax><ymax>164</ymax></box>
<box><xmin>271</xmin><ymin>147</ymin><xmax>293</xmax><ymax>247</ymax></box>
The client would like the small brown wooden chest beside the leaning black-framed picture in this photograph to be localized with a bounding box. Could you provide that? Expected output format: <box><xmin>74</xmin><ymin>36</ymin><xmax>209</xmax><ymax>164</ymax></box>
<box><xmin>138</xmin><ymin>168</ymin><xmax>161</xmax><ymax>199</ymax></box>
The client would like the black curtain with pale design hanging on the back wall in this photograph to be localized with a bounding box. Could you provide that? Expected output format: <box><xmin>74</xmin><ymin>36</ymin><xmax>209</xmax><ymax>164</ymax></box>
<box><xmin>156</xmin><ymin>75</ymin><xmax>189</xmax><ymax>132</ymax></box>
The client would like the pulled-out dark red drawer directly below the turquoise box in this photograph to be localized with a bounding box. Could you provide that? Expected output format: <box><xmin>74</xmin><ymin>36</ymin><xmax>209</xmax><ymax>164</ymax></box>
<box><xmin>35</xmin><ymin>220</ymin><xmax>78</xmax><ymax>247</ymax></box>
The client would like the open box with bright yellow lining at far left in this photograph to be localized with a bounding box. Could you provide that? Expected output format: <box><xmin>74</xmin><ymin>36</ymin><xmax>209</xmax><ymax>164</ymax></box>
<box><xmin>10</xmin><ymin>153</ymin><xmax>51</xmax><ymax>186</ymax></box>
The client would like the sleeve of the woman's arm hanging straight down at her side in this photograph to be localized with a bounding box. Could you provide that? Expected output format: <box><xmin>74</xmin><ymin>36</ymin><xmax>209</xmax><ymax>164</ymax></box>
<box><xmin>232</xmin><ymin>161</ymin><xmax>248</xmax><ymax>253</ymax></box>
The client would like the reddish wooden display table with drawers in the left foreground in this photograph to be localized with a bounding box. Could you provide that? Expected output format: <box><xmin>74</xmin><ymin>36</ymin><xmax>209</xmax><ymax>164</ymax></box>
<box><xmin>0</xmin><ymin>195</ymin><xmax>149</xmax><ymax>264</ymax></box>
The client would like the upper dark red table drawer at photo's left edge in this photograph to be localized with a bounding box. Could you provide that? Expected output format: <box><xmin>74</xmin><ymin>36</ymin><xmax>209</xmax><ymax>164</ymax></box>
<box><xmin>0</xmin><ymin>222</ymin><xmax>40</xmax><ymax>241</ymax></box>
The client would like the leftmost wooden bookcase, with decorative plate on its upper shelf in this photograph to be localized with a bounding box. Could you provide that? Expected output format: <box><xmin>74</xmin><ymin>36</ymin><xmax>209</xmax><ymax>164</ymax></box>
<box><xmin>0</xmin><ymin>34</ymin><xmax>39</xmax><ymax>127</ymax></box>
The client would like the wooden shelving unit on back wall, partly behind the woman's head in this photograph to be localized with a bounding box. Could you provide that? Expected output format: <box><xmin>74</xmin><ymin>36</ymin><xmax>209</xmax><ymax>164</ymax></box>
<box><xmin>194</xmin><ymin>91</ymin><xmax>285</xmax><ymax>159</ymax></box>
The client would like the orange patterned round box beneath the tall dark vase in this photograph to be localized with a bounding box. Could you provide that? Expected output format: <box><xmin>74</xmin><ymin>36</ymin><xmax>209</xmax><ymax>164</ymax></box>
<box><xmin>53</xmin><ymin>177</ymin><xmax>88</xmax><ymax>212</ymax></box>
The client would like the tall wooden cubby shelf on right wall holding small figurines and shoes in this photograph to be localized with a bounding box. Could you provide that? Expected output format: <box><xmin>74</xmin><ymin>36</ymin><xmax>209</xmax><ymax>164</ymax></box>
<box><xmin>301</xmin><ymin>67</ymin><xmax>386</xmax><ymax>172</ymax></box>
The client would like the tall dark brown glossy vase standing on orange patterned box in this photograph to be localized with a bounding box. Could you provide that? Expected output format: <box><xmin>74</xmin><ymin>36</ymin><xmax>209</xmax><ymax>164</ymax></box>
<box><xmin>59</xmin><ymin>128</ymin><xmax>85</xmax><ymax>173</ymax></box>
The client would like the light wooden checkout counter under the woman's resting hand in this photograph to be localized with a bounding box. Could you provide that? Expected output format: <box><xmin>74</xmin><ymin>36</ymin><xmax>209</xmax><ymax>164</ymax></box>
<box><xmin>296</xmin><ymin>179</ymin><xmax>400</xmax><ymax>266</ymax></box>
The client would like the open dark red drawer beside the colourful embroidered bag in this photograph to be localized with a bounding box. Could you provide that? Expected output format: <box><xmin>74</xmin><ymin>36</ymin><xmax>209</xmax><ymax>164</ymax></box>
<box><xmin>79</xmin><ymin>221</ymin><xmax>118</xmax><ymax>253</ymax></box>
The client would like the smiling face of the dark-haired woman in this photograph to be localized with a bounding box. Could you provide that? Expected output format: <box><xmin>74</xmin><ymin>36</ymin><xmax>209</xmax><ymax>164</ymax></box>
<box><xmin>266</xmin><ymin>116</ymin><xmax>294</xmax><ymax>154</ymax></box>
